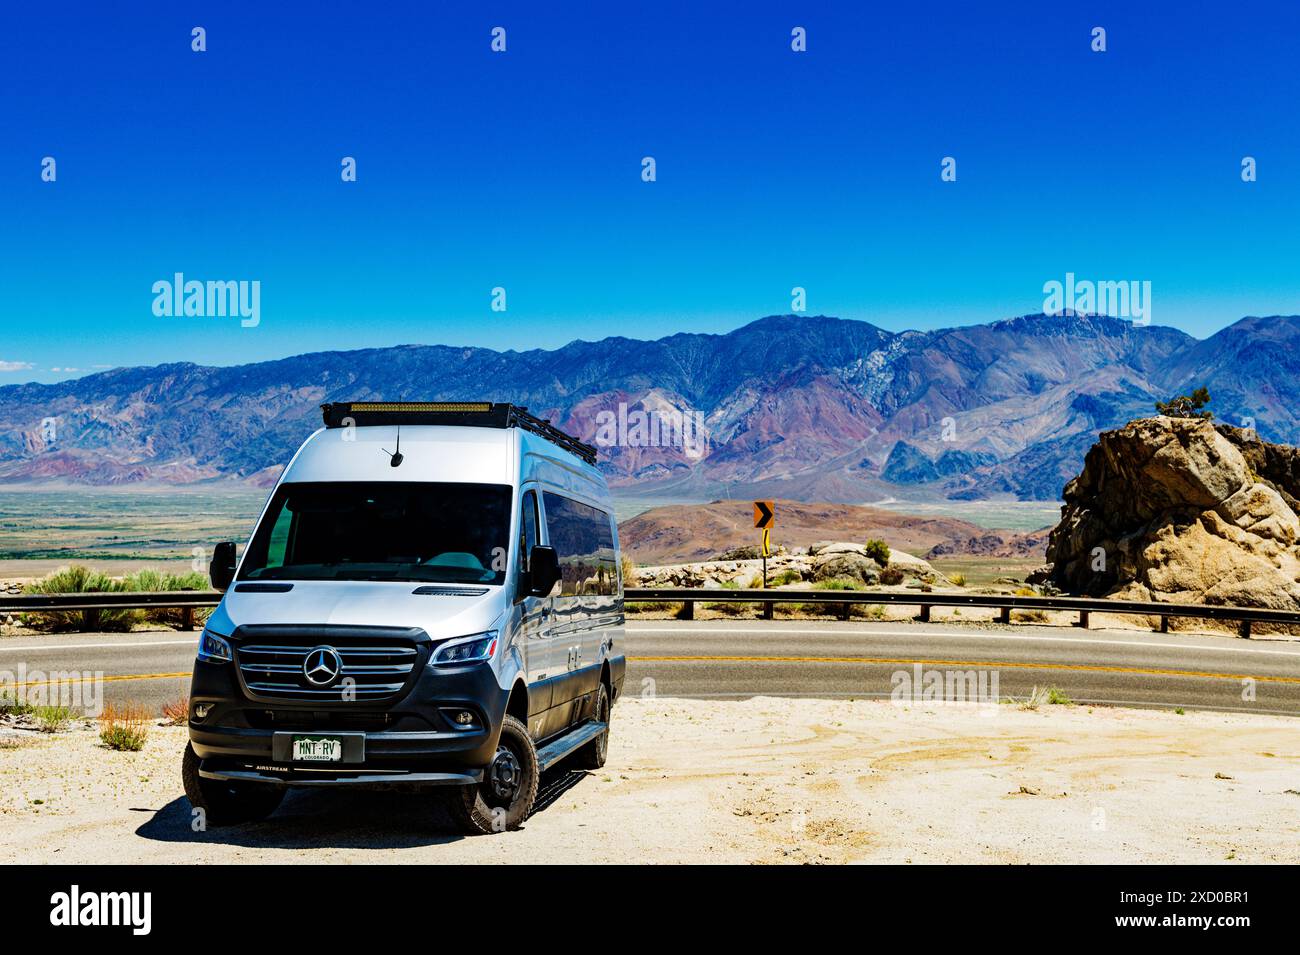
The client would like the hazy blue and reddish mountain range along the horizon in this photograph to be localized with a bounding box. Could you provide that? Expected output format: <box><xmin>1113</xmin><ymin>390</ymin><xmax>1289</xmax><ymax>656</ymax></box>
<box><xmin>0</xmin><ymin>313</ymin><xmax>1300</xmax><ymax>502</ymax></box>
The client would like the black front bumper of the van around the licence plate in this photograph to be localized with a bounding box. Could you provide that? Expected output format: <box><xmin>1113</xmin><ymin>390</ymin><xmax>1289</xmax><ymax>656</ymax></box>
<box><xmin>190</xmin><ymin>655</ymin><xmax>510</xmax><ymax>786</ymax></box>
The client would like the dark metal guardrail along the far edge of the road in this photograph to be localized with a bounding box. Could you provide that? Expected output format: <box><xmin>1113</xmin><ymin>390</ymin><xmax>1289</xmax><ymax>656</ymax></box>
<box><xmin>0</xmin><ymin>587</ymin><xmax>1300</xmax><ymax>637</ymax></box>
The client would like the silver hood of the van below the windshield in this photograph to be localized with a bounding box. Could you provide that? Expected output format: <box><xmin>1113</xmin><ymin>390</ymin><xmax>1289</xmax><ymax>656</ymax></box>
<box><xmin>207</xmin><ymin>581</ymin><xmax>507</xmax><ymax>641</ymax></box>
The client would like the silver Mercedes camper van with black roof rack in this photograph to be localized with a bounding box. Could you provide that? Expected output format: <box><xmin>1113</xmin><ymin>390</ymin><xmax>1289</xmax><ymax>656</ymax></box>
<box><xmin>182</xmin><ymin>401</ymin><xmax>625</xmax><ymax>833</ymax></box>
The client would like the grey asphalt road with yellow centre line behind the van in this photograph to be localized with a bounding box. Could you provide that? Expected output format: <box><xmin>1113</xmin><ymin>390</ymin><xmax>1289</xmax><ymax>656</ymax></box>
<box><xmin>0</xmin><ymin>621</ymin><xmax>1300</xmax><ymax>715</ymax></box>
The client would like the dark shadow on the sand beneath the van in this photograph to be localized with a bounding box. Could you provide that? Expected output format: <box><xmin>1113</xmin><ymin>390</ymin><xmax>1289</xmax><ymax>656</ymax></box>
<box><xmin>135</xmin><ymin>768</ymin><xmax>590</xmax><ymax>848</ymax></box>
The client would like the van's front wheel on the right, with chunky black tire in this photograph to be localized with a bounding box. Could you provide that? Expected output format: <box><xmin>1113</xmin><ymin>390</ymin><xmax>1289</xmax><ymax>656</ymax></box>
<box><xmin>449</xmin><ymin>716</ymin><xmax>541</xmax><ymax>835</ymax></box>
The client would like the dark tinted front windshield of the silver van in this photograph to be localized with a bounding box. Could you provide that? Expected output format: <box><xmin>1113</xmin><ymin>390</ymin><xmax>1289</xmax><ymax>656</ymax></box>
<box><xmin>239</xmin><ymin>482</ymin><xmax>512</xmax><ymax>583</ymax></box>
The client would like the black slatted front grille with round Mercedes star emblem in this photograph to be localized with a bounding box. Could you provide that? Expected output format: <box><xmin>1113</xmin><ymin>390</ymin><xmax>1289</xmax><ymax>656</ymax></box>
<box><xmin>228</xmin><ymin>628</ymin><xmax>421</xmax><ymax>703</ymax></box>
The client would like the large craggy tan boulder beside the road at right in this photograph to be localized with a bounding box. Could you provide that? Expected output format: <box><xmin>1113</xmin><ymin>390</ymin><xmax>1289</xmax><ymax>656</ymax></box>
<box><xmin>1035</xmin><ymin>417</ymin><xmax>1300</xmax><ymax>609</ymax></box>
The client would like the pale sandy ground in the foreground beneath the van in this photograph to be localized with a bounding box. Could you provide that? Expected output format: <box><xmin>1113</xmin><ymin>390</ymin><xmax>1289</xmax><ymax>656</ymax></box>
<box><xmin>0</xmin><ymin>698</ymin><xmax>1300</xmax><ymax>864</ymax></box>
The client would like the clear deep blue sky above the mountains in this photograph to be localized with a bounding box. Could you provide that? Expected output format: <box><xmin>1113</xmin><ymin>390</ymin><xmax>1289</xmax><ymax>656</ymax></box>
<box><xmin>0</xmin><ymin>3</ymin><xmax>1300</xmax><ymax>383</ymax></box>
